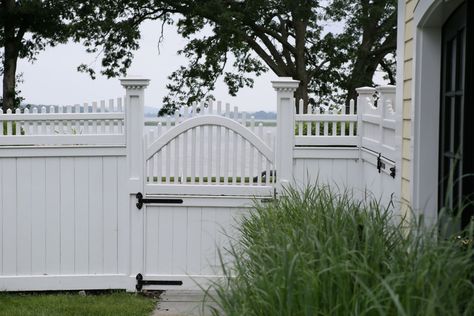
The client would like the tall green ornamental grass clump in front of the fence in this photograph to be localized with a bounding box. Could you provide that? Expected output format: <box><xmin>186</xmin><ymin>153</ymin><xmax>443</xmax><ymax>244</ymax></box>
<box><xmin>210</xmin><ymin>186</ymin><xmax>474</xmax><ymax>316</ymax></box>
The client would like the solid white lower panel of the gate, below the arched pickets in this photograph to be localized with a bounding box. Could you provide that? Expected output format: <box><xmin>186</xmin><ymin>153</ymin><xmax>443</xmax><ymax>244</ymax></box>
<box><xmin>144</xmin><ymin>197</ymin><xmax>248</xmax><ymax>289</ymax></box>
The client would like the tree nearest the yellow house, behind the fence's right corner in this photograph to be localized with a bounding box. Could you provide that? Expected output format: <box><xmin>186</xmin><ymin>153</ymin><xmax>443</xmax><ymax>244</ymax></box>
<box><xmin>326</xmin><ymin>0</ymin><xmax>397</xmax><ymax>104</ymax></box>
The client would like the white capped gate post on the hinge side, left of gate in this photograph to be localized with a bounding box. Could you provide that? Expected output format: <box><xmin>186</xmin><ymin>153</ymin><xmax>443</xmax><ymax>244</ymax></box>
<box><xmin>120</xmin><ymin>78</ymin><xmax>150</xmax><ymax>290</ymax></box>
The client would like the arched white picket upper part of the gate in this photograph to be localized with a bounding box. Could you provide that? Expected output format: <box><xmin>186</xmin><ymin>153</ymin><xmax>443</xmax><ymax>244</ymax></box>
<box><xmin>145</xmin><ymin>102</ymin><xmax>275</xmax><ymax>195</ymax></box>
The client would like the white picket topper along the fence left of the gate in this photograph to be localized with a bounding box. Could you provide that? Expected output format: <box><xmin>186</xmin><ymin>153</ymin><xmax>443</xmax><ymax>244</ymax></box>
<box><xmin>0</xmin><ymin>98</ymin><xmax>125</xmax><ymax>146</ymax></box>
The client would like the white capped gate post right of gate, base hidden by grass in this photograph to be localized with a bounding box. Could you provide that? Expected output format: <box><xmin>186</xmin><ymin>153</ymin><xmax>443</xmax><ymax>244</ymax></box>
<box><xmin>272</xmin><ymin>77</ymin><xmax>299</xmax><ymax>192</ymax></box>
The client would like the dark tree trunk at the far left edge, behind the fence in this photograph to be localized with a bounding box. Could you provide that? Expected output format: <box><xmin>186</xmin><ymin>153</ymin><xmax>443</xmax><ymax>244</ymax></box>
<box><xmin>2</xmin><ymin>0</ymin><xmax>19</xmax><ymax>112</ymax></box>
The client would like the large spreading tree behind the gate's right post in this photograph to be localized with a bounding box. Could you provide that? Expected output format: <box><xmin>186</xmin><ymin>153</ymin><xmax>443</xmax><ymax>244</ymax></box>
<box><xmin>156</xmin><ymin>0</ymin><xmax>343</xmax><ymax>111</ymax></box>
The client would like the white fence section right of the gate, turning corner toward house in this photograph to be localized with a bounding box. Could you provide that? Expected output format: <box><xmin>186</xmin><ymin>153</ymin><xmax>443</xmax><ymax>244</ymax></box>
<box><xmin>293</xmin><ymin>86</ymin><xmax>400</xmax><ymax>205</ymax></box>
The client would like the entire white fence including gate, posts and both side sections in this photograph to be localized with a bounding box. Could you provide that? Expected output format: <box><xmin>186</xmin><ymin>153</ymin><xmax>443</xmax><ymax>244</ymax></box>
<box><xmin>0</xmin><ymin>78</ymin><xmax>400</xmax><ymax>291</ymax></box>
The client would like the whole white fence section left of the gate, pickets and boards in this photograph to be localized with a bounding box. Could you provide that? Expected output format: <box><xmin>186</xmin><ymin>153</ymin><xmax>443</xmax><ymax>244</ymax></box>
<box><xmin>0</xmin><ymin>99</ymin><xmax>129</xmax><ymax>291</ymax></box>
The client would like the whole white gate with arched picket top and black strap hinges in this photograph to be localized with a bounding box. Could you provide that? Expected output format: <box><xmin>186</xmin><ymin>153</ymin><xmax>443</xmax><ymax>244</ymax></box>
<box><xmin>138</xmin><ymin>103</ymin><xmax>274</xmax><ymax>289</ymax></box>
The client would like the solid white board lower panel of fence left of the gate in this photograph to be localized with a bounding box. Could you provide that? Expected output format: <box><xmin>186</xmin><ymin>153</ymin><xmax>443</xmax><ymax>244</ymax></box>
<box><xmin>0</xmin><ymin>154</ymin><xmax>129</xmax><ymax>290</ymax></box>
